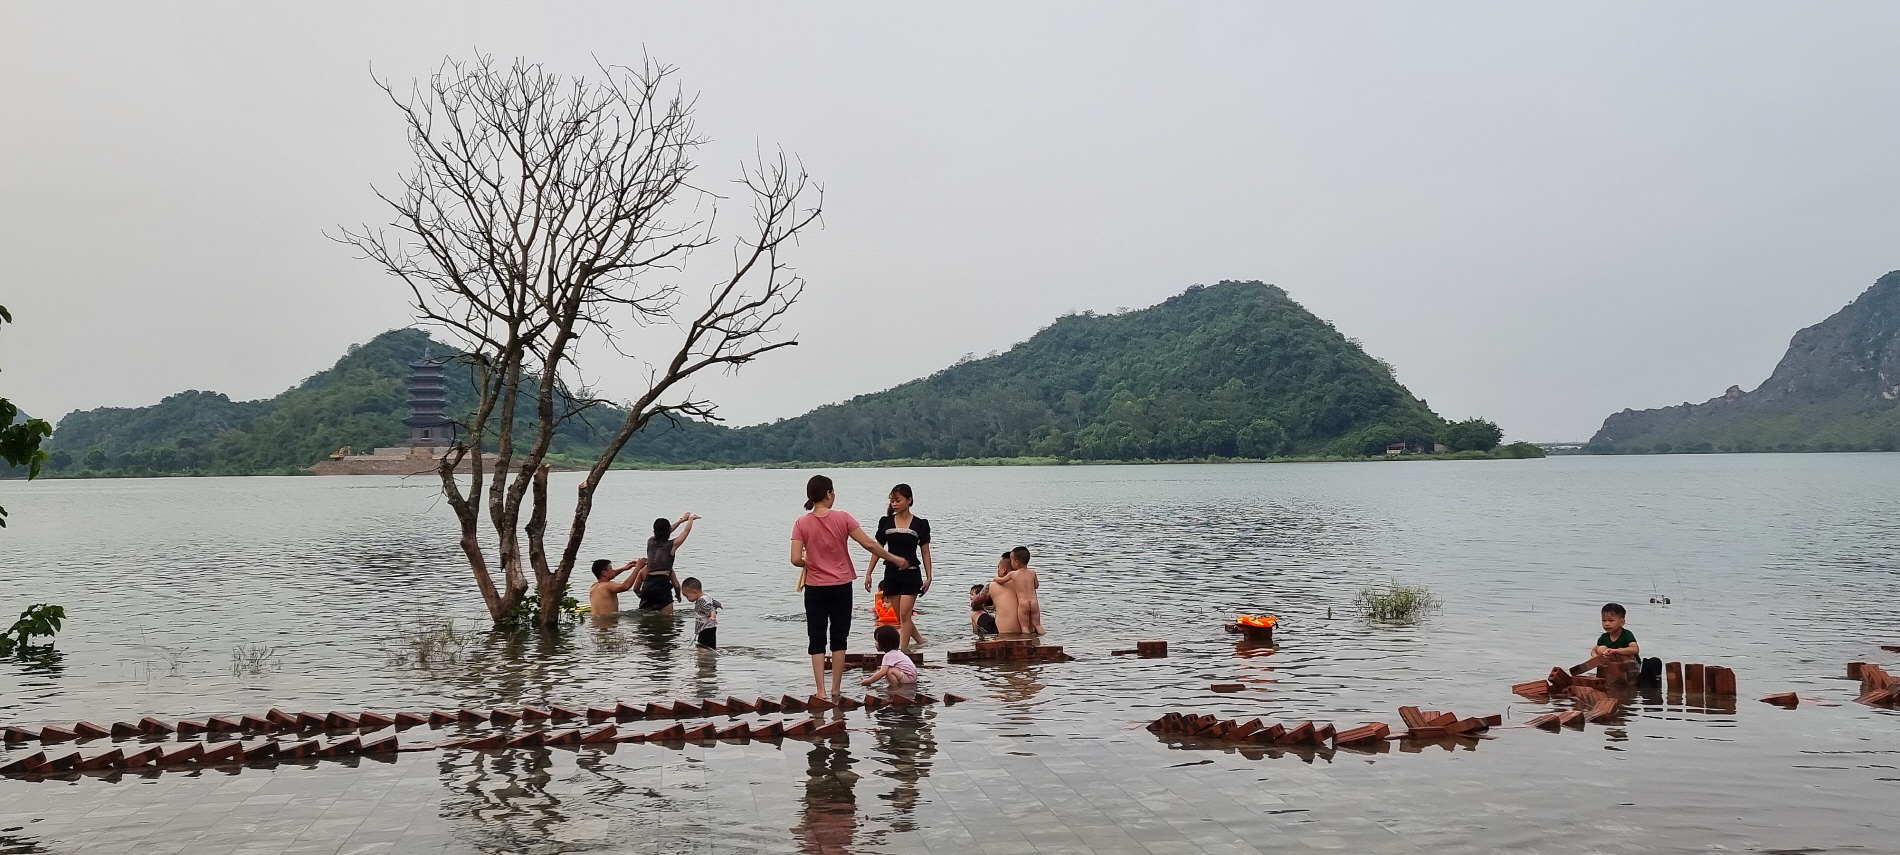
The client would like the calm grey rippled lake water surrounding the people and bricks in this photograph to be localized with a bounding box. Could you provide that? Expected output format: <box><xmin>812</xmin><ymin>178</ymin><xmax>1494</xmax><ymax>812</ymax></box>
<box><xmin>0</xmin><ymin>454</ymin><xmax>1900</xmax><ymax>851</ymax></box>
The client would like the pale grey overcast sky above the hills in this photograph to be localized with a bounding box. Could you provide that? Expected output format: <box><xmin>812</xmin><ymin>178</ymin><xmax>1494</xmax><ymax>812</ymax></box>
<box><xmin>0</xmin><ymin>0</ymin><xmax>1900</xmax><ymax>441</ymax></box>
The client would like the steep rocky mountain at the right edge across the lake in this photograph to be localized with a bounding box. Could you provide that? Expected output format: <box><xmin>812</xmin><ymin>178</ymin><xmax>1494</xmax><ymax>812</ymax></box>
<box><xmin>1585</xmin><ymin>270</ymin><xmax>1900</xmax><ymax>454</ymax></box>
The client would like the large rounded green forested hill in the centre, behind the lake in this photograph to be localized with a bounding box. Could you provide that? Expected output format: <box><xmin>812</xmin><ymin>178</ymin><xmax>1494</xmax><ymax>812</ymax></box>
<box><xmin>695</xmin><ymin>281</ymin><xmax>1444</xmax><ymax>462</ymax></box>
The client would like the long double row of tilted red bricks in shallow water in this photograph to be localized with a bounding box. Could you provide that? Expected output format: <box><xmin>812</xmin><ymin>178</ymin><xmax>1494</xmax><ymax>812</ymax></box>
<box><xmin>0</xmin><ymin>694</ymin><xmax>963</xmax><ymax>777</ymax></box>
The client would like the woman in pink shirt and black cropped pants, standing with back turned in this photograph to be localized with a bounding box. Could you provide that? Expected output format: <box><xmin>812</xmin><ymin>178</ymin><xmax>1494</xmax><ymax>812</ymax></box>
<box><xmin>792</xmin><ymin>475</ymin><xmax>910</xmax><ymax>697</ymax></box>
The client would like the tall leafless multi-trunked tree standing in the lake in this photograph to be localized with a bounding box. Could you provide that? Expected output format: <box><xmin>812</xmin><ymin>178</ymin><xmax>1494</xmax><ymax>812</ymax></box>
<box><xmin>340</xmin><ymin>57</ymin><xmax>823</xmax><ymax>627</ymax></box>
